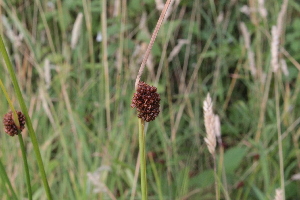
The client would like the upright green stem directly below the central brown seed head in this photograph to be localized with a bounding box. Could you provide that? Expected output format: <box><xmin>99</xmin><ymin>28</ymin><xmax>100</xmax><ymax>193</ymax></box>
<box><xmin>139</xmin><ymin>118</ymin><xmax>147</xmax><ymax>200</ymax></box>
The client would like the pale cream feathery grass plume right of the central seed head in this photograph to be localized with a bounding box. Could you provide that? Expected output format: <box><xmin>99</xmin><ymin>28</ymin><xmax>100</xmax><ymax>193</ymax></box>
<box><xmin>203</xmin><ymin>93</ymin><xmax>216</xmax><ymax>155</ymax></box>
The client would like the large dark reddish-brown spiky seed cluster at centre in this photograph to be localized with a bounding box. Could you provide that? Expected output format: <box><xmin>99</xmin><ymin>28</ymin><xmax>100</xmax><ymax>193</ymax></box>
<box><xmin>131</xmin><ymin>81</ymin><xmax>160</xmax><ymax>122</ymax></box>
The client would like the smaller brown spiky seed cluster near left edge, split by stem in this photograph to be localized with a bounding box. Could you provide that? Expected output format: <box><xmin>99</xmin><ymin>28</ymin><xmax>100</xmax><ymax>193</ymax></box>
<box><xmin>3</xmin><ymin>111</ymin><xmax>25</xmax><ymax>136</ymax></box>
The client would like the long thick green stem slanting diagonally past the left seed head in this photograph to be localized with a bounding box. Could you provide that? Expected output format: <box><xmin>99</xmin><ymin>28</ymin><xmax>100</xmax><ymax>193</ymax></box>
<box><xmin>0</xmin><ymin>35</ymin><xmax>52</xmax><ymax>200</ymax></box>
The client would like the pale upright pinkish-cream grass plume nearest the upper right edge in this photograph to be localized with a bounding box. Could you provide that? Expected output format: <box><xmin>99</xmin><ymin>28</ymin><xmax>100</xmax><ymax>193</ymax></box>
<box><xmin>271</xmin><ymin>26</ymin><xmax>279</xmax><ymax>73</ymax></box>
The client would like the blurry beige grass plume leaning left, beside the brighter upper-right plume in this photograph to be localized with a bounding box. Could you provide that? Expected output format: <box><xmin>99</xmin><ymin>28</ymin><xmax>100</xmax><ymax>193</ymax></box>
<box><xmin>240</xmin><ymin>22</ymin><xmax>256</xmax><ymax>76</ymax></box>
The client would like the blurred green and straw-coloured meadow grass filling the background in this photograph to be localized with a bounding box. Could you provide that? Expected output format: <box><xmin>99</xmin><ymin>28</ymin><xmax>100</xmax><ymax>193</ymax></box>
<box><xmin>0</xmin><ymin>0</ymin><xmax>300</xmax><ymax>200</ymax></box>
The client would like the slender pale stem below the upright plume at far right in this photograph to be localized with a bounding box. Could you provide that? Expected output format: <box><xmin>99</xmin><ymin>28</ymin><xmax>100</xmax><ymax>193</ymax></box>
<box><xmin>275</xmin><ymin>73</ymin><xmax>285</xmax><ymax>200</ymax></box>
